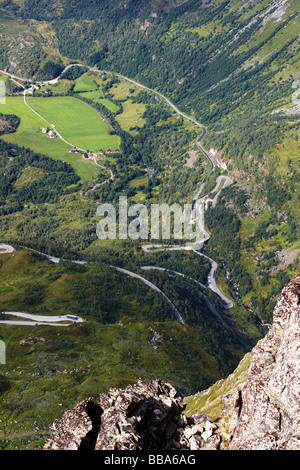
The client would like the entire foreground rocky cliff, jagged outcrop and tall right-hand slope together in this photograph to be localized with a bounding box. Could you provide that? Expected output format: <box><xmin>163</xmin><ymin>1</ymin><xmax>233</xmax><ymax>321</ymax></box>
<box><xmin>44</xmin><ymin>276</ymin><xmax>300</xmax><ymax>450</ymax></box>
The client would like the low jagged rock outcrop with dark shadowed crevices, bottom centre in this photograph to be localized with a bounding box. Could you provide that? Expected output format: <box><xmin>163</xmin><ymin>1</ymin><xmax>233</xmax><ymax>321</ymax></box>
<box><xmin>44</xmin><ymin>380</ymin><xmax>221</xmax><ymax>450</ymax></box>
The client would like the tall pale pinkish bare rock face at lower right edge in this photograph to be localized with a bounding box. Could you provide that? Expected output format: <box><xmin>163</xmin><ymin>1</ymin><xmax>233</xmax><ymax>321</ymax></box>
<box><xmin>230</xmin><ymin>276</ymin><xmax>300</xmax><ymax>450</ymax></box>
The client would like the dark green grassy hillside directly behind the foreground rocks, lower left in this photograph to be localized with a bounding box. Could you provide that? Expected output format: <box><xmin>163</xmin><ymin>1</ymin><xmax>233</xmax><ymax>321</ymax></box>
<box><xmin>0</xmin><ymin>250</ymin><xmax>251</xmax><ymax>449</ymax></box>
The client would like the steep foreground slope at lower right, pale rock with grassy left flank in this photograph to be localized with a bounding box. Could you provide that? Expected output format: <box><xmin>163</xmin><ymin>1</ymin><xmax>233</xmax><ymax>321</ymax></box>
<box><xmin>186</xmin><ymin>276</ymin><xmax>300</xmax><ymax>450</ymax></box>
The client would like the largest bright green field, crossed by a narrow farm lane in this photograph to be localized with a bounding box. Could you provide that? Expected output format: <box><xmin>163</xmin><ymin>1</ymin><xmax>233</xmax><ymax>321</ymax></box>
<box><xmin>1</xmin><ymin>96</ymin><xmax>120</xmax><ymax>180</ymax></box>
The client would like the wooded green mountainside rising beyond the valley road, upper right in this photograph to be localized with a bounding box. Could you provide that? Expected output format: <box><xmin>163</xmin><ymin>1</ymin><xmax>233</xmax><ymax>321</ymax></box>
<box><xmin>0</xmin><ymin>0</ymin><xmax>300</xmax><ymax>321</ymax></box>
